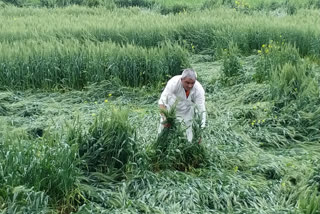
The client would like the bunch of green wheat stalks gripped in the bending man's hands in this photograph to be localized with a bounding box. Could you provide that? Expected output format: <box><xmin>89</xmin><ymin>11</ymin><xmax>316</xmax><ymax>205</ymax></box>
<box><xmin>150</xmin><ymin>106</ymin><xmax>208</xmax><ymax>171</ymax></box>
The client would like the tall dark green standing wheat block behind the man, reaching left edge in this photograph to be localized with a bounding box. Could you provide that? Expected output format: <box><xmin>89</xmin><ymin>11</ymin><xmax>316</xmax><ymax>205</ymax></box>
<box><xmin>0</xmin><ymin>40</ymin><xmax>188</xmax><ymax>89</ymax></box>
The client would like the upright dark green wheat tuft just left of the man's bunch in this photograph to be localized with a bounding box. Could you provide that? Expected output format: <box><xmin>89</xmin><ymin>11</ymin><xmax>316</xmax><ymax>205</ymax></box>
<box><xmin>68</xmin><ymin>109</ymin><xmax>137</xmax><ymax>172</ymax></box>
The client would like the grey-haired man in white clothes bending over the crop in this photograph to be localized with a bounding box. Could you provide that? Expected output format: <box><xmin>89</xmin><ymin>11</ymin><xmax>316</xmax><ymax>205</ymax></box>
<box><xmin>158</xmin><ymin>68</ymin><xmax>206</xmax><ymax>142</ymax></box>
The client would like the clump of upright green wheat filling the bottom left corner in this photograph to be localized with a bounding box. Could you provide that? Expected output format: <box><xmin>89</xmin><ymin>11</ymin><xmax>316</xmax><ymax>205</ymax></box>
<box><xmin>0</xmin><ymin>132</ymin><xmax>81</xmax><ymax>213</ymax></box>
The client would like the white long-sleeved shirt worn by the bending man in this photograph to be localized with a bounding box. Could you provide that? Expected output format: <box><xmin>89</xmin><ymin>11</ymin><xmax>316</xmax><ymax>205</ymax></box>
<box><xmin>158</xmin><ymin>75</ymin><xmax>206</xmax><ymax>127</ymax></box>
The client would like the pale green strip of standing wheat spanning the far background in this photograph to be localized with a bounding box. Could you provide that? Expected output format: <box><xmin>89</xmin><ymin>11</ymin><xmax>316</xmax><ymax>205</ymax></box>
<box><xmin>0</xmin><ymin>7</ymin><xmax>320</xmax><ymax>56</ymax></box>
